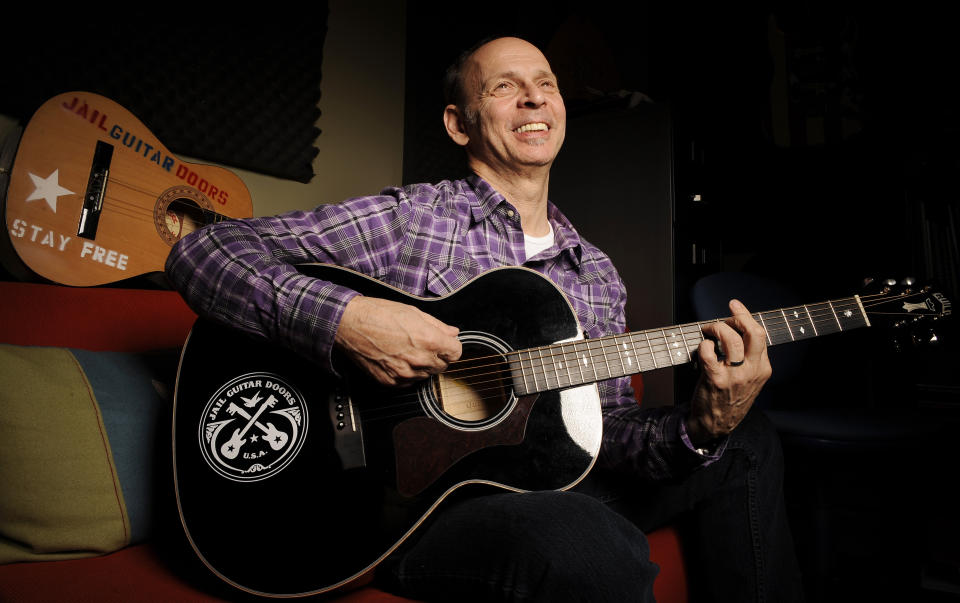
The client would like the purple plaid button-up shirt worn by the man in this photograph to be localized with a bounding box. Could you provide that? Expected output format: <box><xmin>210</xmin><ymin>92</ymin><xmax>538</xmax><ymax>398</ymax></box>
<box><xmin>166</xmin><ymin>176</ymin><xmax>715</xmax><ymax>479</ymax></box>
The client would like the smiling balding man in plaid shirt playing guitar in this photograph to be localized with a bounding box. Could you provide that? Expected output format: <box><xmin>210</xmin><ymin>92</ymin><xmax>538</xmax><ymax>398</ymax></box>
<box><xmin>167</xmin><ymin>38</ymin><xmax>801</xmax><ymax>602</ymax></box>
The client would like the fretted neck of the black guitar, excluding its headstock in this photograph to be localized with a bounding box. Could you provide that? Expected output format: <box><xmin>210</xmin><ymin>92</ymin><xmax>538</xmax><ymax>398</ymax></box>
<box><xmin>509</xmin><ymin>296</ymin><xmax>870</xmax><ymax>395</ymax></box>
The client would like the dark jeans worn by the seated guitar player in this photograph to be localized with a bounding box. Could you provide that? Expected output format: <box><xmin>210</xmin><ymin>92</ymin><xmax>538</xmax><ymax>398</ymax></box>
<box><xmin>379</xmin><ymin>411</ymin><xmax>803</xmax><ymax>602</ymax></box>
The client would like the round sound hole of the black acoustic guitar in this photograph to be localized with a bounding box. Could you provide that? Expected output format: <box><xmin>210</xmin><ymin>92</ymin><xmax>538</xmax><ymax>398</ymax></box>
<box><xmin>421</xmin><ymin>333</ymin><xmax>516</xmax><ymax>428</ymax></box>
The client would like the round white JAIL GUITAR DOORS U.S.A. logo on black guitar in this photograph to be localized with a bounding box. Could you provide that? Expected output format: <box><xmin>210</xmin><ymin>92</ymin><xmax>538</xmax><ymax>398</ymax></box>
<box><xmin>198</xmin><ymin>373</ymin><xmax>307</xmax><ymax>482</ymax></box>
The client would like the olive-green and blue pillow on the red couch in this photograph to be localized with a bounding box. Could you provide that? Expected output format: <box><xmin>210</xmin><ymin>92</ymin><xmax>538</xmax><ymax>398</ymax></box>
<box><xmin>0</xmin><ymin>344</ymin><xmax>174</xmax><ymax>563</ymax></box>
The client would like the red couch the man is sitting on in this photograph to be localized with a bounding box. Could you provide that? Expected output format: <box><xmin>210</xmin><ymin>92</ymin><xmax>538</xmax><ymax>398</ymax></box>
<box><xmin>0</xmin><ymin>282</ymin><xmax>687</xmax><ymax>602</ymax></box>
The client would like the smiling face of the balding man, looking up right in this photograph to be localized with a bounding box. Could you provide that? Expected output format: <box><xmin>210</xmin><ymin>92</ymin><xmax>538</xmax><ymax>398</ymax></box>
<box><xmin>463</xmin><ymin>38</ymin><xmax>566</xmax><ymax>172</ymax></box>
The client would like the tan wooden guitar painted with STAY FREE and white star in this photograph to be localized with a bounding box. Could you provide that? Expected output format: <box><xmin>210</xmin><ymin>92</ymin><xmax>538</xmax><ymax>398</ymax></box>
<box><xmin>5</xmin><ymin>92</ymin><xmax>253</xmax><ymax>286</ymax></box>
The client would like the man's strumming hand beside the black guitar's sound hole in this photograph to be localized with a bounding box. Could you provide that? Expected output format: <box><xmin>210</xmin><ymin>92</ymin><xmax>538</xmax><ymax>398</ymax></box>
<box><xmin>334</xmin><ymin>296</ymin><xmax>462</xmax><ymax>386</ymax></box>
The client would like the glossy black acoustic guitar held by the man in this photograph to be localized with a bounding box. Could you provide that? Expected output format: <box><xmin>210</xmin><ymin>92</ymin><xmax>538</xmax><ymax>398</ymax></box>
<box><xmin>173</xmin><ymin>265</ymin><xmax>950</xmax><ymax>597</ymax></box>
